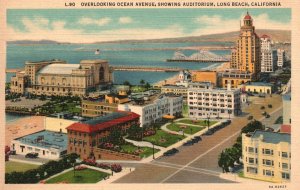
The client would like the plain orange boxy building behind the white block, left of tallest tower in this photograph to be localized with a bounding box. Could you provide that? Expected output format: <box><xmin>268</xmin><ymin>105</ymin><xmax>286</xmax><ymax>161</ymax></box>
<box><xmin>192</xmin><ymin>71</ymin><xmax>218</xmax><ymax>86</ymax></box>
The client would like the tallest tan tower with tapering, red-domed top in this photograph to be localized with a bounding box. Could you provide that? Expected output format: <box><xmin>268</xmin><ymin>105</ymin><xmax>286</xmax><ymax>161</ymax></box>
<box><xmin>231</xmin><ymin>12</ymin><xmax>261</xmax><ymax>76</ymax></box>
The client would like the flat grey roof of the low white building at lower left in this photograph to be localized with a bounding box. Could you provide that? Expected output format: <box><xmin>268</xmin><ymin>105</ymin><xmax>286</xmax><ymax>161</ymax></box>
<box><xmin>15</xmin><ymin>131</ymin><xmax>68</xmax><ymax>151</ymax></box>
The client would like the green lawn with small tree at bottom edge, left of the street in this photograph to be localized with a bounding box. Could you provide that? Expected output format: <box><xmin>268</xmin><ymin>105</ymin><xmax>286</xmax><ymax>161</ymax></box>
<box><xmin>46</xmin><ymin>168</ymin><xmax>109</xmax><ymax>183</ymax></box>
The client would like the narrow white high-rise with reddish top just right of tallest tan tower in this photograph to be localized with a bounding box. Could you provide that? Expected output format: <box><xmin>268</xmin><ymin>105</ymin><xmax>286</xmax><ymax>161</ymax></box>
<box><xmin>260</xmin><ymin>34</ymin><xmax>274</xmax><ymax>73</ymax></box>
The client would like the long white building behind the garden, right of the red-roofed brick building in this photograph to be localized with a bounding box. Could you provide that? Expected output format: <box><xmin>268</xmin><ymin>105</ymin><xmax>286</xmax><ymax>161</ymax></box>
<box><xmin>118</xmin><ymin>94</ymin><xmax>183</xmax><ymax>127</ymax></box>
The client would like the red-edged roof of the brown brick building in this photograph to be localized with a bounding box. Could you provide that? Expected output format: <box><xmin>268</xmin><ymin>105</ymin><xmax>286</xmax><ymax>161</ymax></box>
<box><xmin>67</xmin><ymin>112</ymin><xmax>140</xmax><ymax>133</ymax></box>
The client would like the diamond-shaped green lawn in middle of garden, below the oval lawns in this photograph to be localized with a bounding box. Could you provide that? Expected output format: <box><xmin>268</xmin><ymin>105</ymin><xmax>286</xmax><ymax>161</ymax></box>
<box><xmin>143</xmin><ymin>130</ymin><xmax>185</xmax><ymax>147</ymax></box>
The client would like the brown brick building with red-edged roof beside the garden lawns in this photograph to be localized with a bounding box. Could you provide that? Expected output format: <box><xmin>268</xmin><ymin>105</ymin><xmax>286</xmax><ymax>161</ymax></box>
<box><xmin>67</xmin><ymin>111</ymin><xmax>140</xmax><ymax>159</ymax></box>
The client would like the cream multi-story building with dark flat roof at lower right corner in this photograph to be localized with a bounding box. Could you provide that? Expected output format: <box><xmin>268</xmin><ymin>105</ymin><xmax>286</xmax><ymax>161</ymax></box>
<box><xmin>242</xmin><ymin>130</ymin><xmax>291</xmax><ymax>183</ymax></box>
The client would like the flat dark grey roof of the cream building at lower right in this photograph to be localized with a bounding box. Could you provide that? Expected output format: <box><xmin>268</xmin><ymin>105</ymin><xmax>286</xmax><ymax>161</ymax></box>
<box><xmin>251</xmin><ymin>130</ymin><xmax>291</xmax><ymax>144</ymax></box>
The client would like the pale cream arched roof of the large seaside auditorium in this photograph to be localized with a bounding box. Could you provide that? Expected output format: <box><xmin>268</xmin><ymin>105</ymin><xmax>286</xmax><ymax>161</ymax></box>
<box><xmin>38</xmin><ymin>63</ymin><xmax>80</xmax><ymax>75</ymax></box>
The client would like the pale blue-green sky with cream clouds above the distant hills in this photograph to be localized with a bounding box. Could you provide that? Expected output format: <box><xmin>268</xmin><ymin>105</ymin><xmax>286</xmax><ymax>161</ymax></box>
<box><xmin>7</xmin><ymin>8</ymin><xmax>291</xmax><ymax>42</ymax></box>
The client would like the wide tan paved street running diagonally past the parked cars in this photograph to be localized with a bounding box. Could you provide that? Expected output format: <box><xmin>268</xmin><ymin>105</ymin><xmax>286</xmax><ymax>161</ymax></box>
<box><xmin>115</xmin><ymin>95</ymin><xmax>282</xmax><ymax>183</ymax></box>
